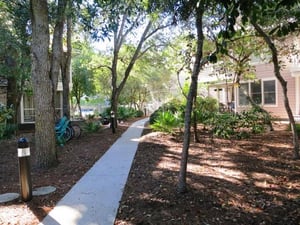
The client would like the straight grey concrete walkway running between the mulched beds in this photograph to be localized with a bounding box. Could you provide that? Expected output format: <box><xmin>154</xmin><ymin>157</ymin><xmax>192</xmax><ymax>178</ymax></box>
<box><xmin>40</xmin><ymin>119</ymin><xmax>148</xmax><ymax>225</ymax></box>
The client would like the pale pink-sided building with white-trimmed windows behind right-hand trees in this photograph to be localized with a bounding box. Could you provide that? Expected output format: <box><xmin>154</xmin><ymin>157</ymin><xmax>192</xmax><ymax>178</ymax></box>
<box><xmin>199</xmin><ymin>48</ymin><xmax>300</xmax><ymax>120</ymax></box>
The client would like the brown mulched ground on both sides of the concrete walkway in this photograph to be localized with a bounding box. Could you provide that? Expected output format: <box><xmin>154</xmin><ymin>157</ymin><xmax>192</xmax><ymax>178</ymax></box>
<box><xmin>0</xmin><ymin>120</ymin><xmax>300</xmax><ymax>225</ymax></box>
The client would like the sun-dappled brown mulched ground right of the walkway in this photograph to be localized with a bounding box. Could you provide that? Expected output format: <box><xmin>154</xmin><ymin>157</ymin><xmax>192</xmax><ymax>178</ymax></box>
<box><xmin>115</xmin><ymin>124</ymin><xmax>300</xmax><ymax>225</ymax></box>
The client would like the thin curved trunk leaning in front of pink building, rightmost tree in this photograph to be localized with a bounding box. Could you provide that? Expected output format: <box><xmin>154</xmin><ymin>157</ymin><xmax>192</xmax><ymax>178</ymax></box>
<box><xmin>252</xmin><ymin>21</ymin><xmax>300</xmax><ymax>159</ymax></box>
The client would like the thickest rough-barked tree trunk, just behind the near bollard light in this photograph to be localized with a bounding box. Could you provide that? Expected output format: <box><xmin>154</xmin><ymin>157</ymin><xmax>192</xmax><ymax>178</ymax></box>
<box><xmin>30</xmin><ymin>0</ymin><xmax>57</xmax><ymax>168</ymax></box>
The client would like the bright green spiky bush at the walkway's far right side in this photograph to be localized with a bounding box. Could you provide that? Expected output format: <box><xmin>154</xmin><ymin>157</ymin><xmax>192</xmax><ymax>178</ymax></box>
<box><xmin>151</xmin><ymin>111</ymin><xmax>183</xmax><ymax>133</ymax></box>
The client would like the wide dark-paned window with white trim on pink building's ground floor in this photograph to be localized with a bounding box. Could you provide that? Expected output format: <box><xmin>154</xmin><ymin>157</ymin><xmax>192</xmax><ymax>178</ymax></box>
<box><xmin>238</xmin><ymin>80</ymin><xmax>276</xmax><ymax>106</ymax></box>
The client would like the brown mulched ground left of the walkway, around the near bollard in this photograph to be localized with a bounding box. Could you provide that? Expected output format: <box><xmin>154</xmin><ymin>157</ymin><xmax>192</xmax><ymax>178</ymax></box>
<box><xmin>0</xmin><ymin>121</ymin><xmax>132</xmax><ymax>225</ymax></box>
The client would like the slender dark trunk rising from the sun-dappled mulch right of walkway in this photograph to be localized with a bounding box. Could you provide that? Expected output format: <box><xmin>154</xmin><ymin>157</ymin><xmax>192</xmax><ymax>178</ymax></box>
<box><xmin>177</xmin><ymin>7</ymin><xmax>204</xmax><ymax>193</ymax></box>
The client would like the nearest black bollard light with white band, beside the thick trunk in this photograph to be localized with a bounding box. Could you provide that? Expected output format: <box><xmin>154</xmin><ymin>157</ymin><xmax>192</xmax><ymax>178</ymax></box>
<box><xmin>18</xmin><ymin>138</ymin><xmax>32</xmax><ymax>202</ymax></box>
